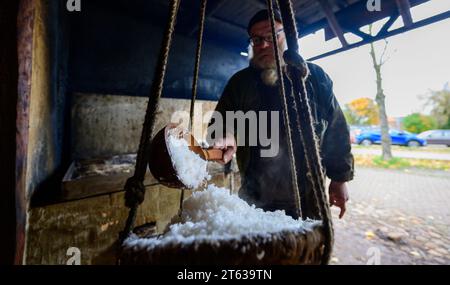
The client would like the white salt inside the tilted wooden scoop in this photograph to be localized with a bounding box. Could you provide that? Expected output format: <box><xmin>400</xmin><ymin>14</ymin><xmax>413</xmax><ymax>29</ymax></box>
<box><xmin>167</xmin><ymin>134</ymin><xmax>211</xmax><ymax>188</ymax></box>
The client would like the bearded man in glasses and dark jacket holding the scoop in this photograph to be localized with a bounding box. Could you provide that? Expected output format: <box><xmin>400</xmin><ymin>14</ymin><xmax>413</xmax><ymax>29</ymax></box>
<box><xmin>209</xmin><ymin>10</ymin><xmax>353</xmax><ymax>218</ymax></box>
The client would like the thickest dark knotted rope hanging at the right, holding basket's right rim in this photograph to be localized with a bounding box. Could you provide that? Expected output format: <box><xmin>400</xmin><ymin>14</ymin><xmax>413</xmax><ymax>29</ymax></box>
<box><xmin>269</xmin><ymin>0</ymin><xmax>334</xmax><ymax>264</ymax></box>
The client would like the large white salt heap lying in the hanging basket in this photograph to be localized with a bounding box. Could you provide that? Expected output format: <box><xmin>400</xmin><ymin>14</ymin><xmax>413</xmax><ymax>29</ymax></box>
<box><xmin>124</xmin><ymin>185</ymin><xmax>320</xmax><ymax>249</ymax></box>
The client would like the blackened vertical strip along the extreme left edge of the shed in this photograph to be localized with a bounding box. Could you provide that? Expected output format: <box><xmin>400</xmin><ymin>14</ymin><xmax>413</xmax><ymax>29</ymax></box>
<box><xmin>0</xmin><ymin>1</ymin><xmax>19</xmax><ymax>265</ymax></box>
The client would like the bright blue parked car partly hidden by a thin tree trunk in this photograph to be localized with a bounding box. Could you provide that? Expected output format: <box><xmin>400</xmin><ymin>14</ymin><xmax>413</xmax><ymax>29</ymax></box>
<box><xmin>356</xmin><ymin>129</ymin><xmax>427</xmax><ymax>147</ymax></box>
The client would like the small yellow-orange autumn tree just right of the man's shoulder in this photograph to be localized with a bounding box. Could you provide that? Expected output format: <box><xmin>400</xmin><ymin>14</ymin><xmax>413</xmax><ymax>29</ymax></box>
<box><xmin>344</xmin><ymin>98</ymin><xmax>379</xmax><ymax>126</ymax></box>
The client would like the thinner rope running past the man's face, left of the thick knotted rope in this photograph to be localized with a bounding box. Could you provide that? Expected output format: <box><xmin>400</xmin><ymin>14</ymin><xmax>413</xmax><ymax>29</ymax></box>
<box><xmin>267</xmin><ymin>0</ymin><xmax>302</xmax><ymax>217</ymax></box>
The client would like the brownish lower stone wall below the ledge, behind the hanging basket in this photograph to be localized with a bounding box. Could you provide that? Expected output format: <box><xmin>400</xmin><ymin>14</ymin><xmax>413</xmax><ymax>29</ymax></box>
<box><xmin>26</xmin><ymin>171</ymin><xmax>238</xmax><ymax>265</ymax></box>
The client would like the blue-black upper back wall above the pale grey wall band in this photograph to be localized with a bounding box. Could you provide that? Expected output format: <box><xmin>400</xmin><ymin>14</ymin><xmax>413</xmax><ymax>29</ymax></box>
<box><xmin>69</xmin><ymin>0</ymin><xmax>247</xmax><ymax>100</ymax></box>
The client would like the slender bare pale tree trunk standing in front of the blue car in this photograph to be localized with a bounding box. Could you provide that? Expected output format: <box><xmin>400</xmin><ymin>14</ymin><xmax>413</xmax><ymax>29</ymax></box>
<box><xmin>369</xmin><ymin>25</ymin><xmax>392</xmax><ymax>160</ymax></box>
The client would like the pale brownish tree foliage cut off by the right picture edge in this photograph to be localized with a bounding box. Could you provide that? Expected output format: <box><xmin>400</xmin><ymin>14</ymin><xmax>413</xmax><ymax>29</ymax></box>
<box><xmin>426</xmin><ymin>83</ymin><xmax>450</xmax><ymax>129</ymax></box>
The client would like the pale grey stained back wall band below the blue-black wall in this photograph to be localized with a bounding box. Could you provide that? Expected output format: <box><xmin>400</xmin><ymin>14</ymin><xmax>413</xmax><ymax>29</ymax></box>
<box><xmin>72</xmin><ymin>93</ymin><xmax>217</xmax><ymax>159</ymax></box>
